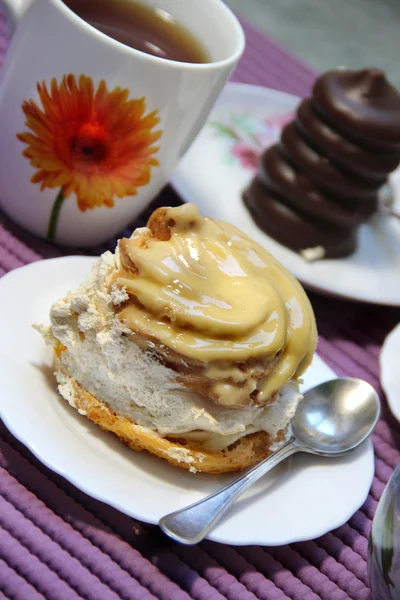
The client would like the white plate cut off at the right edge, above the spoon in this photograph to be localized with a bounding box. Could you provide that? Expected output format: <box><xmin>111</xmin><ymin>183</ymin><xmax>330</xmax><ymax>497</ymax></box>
<box><xmin>380</xmin><ymin>323</ymin><xmax>400</xmax><ymax>422</ymax></box>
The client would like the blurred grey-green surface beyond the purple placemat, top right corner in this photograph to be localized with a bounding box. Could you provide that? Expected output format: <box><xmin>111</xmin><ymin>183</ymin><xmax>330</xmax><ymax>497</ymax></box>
<box><xmin>226</xmin><ymin>0</ymin><xmax>400</xmax><ymax>87</ymax></box>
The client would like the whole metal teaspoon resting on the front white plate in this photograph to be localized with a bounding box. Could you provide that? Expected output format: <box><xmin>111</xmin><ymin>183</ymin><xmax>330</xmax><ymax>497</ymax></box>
<box><xmin>159</xmin><ymin>378</ymin><xmax>380</xmax><ymax>545</ymax></box>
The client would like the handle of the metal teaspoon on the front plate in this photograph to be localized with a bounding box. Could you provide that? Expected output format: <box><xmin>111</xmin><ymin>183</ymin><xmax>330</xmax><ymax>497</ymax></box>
<box><xmin>159</xmin><ymin>436</ymin><xmax>300</xmax><ymax>545</ymax></box>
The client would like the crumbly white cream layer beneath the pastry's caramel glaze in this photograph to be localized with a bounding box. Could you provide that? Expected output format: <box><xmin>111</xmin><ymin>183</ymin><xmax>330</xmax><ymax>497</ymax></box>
<box><xmin>44</xmin><ymin>252</ymin><xmax>302</xmax><ymax>447</ymax></box>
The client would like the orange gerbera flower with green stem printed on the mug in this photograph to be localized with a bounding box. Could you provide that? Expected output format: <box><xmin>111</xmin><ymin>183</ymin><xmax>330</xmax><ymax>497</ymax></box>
<box><xmin>17</xmin><ymin>75</ymin><xmax>162</xmax><ymax>239</ymax></box>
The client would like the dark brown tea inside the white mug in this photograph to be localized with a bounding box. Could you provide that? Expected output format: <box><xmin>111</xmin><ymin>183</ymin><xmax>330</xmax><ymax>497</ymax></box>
<box><xmin>64</xmin><ymin>0</ymin><xmax>210</xmax><ymax>63</ymax></box>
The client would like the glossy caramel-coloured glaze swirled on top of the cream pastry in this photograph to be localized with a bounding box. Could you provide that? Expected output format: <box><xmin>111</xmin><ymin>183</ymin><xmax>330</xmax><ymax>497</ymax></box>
<box><xmin>110</xmin><ymin>204</ymin><xmax>316</xmax><ymax>406</ymax></box>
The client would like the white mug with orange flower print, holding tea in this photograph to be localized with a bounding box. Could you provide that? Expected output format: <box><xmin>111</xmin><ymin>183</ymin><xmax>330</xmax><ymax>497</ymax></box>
<box><xmin>0</xmin><ymin>0</ymin><xmax>245</xmax><ymax>246</ymax></box>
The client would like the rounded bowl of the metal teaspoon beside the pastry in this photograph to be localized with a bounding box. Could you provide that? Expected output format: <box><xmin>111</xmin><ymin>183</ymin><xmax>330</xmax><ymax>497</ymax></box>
<box><xmin>292</xmin><ymin>378</ymin><xmax>380</xmax><ymax>456</ymax></box>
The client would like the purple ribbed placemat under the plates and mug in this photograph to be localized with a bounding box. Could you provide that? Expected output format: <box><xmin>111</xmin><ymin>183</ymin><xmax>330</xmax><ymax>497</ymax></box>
<box><xmin>0</xmin><ymin>5</ymin><xmax>400</xmax><ymax>600</ymax></box>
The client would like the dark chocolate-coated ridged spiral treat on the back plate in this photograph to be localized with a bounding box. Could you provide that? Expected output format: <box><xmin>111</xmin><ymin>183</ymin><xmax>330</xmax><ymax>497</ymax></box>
<box><xmin>244</xmin><ymin>69</ymin><xmax>400</xmax><ymax>259</ymax></box>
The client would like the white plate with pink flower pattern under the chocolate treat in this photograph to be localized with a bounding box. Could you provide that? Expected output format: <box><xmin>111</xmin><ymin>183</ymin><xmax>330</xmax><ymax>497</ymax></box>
<box><xmin>172</xmin><ymin>83</ymin><xmax>400</xmax><ymax>306</ymax></box>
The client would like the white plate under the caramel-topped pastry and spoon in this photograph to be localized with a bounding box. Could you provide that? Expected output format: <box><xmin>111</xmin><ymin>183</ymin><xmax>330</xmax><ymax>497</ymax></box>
<box><xmin>0</xmin><ymin>257</ymin><xmax>374</xmax><ymax>545</ymax></box>
